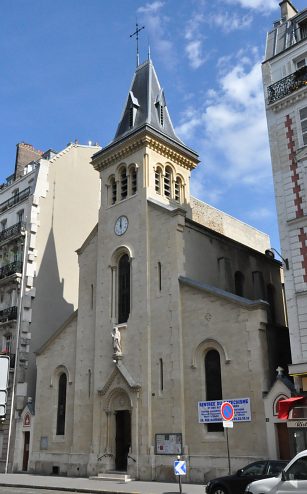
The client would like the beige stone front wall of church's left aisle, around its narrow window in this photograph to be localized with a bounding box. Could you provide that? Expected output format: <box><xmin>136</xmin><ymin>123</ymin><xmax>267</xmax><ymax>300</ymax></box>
<box><xmin>29</xmin><ymin>315</ymin><xmax>77</xmax><ymax>475</ymax></box>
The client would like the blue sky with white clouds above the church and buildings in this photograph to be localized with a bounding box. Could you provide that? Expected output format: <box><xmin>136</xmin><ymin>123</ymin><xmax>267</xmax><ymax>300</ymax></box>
<box><xmin>0</xmin><ymin>0</ymin><xmax>307</xmax><ymax>248</ymax></box>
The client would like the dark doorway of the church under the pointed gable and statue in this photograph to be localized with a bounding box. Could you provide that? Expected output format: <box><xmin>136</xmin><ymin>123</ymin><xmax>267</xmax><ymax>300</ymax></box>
<box><xmin>115</xmin><ymin>410</ymin><xmax>131</xmax><ymax>471</ymax></box>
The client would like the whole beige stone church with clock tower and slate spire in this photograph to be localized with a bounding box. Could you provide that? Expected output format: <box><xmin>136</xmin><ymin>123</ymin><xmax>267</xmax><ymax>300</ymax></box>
<box><xmin>26</xmin><ymin>56</ymin><xmax>290</xmax><ymax>482</ymax></box>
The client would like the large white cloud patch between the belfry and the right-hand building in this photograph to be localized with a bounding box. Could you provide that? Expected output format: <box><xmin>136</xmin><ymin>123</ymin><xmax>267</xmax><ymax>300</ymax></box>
<box><xmin>176</xmin><ymin>47</ymin><xmax>271</xmax><ymax>196</ymax></box>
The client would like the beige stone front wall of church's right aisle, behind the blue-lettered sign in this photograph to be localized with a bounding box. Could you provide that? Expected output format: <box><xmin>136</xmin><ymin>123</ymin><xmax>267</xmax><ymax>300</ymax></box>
<box><xmin>181</xmin><ymin>286</ymin><xmax>269</xmax><ymax>481</ymax></box>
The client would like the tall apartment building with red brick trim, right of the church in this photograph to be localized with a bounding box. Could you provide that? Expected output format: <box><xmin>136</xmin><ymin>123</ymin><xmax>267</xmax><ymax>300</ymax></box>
<box><xmin>263</xmin><ymin>0</ymin><xmax>307</xmax><ymax>453</ymax></box>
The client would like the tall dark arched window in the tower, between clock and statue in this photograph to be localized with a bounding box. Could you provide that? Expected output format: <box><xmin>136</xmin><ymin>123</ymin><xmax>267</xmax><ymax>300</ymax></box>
<box><xmin>118</xmin><ymin>254</ymin><xmax>130</xmax><ymax>324</ymax></box>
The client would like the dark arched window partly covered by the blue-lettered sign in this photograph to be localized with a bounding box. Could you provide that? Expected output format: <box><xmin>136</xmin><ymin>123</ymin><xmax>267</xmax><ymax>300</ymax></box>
<box><xmin>205</xmin><ymin>350</ymin><xmax>223</xmax><ymax>432</ymax></box>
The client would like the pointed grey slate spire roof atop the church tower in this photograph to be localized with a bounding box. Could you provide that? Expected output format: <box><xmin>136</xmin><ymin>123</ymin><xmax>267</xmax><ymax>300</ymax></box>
<box><xmin>113</xmin><ymin>59</ymin><xmax>183</xmax><ymax>145</ymax></box>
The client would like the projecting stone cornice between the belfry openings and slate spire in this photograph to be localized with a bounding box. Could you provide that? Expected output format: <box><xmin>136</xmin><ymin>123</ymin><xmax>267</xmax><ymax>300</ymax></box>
<box><xmin>92</xmin><ymin>130</ymin><xmax>199</xmax><ymax>171</ymax></box>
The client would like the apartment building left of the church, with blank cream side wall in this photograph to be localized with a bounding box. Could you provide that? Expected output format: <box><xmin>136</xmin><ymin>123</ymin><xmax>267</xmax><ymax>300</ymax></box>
<box><xmin>0</xmin><ymin>143</ymin><xmax>100</xmax><ymax>471</ymax></box>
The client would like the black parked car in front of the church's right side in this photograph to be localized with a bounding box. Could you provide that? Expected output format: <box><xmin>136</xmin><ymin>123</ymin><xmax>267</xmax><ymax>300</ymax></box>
<box><xmin>206</xmin><ymin>460</ymin><xmax>290</xmax><ymax>494</ymax></box>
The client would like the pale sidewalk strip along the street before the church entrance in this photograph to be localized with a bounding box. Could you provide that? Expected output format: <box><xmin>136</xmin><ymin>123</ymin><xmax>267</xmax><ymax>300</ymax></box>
<box><xmin>0</xmin><ymin>473</ymin><xmax>205</xmax><ymax>494</ymax></box>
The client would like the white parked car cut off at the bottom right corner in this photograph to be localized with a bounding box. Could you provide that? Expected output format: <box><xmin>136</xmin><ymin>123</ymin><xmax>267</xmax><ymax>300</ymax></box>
<box><xmin>245</xmin><ymin>449</ymin><xmax>307</xmax><ymax>494</ymax></box>
